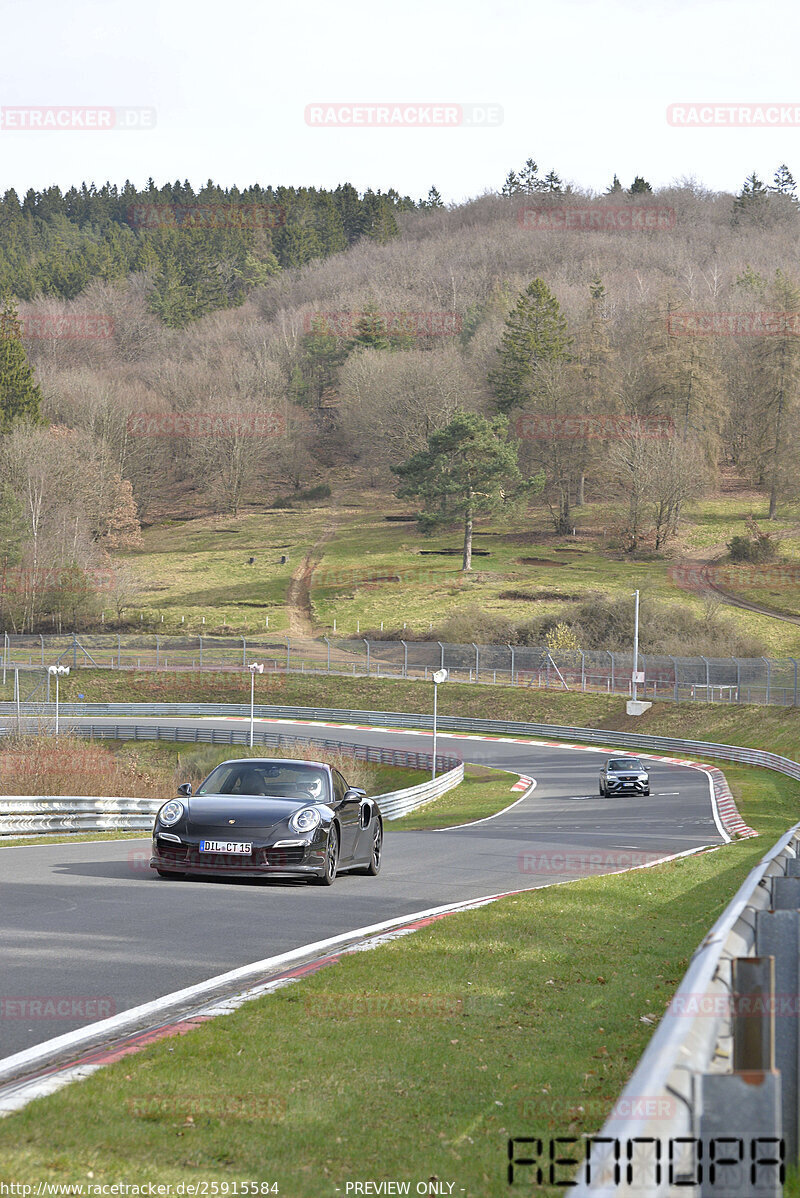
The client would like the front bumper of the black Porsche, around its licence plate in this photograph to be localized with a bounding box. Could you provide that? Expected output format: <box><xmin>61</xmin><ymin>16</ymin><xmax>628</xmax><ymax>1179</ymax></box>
<box><xmin>150</xmin><ymin>828</ymin><xmax>326</xmax><ymax>878</ymax></box>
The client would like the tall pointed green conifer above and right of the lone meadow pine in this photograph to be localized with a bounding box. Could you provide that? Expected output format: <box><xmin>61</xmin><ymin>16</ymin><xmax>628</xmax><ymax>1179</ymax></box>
<box><xmin>489</xmin><ymin>279</ymin><xmax>571</xmax><ymax>412</ymax></box>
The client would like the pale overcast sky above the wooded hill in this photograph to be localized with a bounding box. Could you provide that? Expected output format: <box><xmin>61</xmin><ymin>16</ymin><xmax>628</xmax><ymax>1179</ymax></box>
<box><xmin>0</xmin><ymin>0</ymin><xmax>800</xmax><ymax>200</ymax></box>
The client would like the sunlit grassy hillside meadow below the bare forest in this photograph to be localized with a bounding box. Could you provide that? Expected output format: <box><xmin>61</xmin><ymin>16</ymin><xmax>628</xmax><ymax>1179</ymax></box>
<box><xmin>95</xmin><ymin>495</ymin><xmax>800</xmax><ymax>654</ymax></box>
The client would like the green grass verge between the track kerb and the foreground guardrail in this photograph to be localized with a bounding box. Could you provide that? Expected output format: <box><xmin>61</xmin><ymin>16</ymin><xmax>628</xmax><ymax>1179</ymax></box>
<box><xmin>0</xmin><ymin>769</ymin><xmax>800</xmax><ymax>1198</ymax></box>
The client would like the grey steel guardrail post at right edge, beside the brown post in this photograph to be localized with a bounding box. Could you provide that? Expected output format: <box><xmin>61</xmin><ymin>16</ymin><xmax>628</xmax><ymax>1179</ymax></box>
<box><xmin>756</xmin><ymin>910</ymin><xmax>800</xmax><ymax>1163</ymax></box>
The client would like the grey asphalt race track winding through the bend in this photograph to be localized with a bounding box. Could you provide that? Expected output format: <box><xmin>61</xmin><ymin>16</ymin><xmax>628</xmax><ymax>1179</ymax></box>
<box><xmin>0</xmin><ymin>719</ymin><xmax>722</xmax><ymax>1058</ymax></box>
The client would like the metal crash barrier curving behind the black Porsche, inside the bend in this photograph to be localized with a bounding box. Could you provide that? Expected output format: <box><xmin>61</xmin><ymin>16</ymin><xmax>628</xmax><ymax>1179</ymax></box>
<box><xmin>0</xmin><ymin>724</ymin><xmax>463</xmax><ymax>837</ymax></box>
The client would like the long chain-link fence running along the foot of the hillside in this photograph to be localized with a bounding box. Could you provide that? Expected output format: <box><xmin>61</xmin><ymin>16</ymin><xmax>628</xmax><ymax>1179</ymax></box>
<box><xmin>2</xmin><ymin>634</ymin><xmax>798</xmax><ymax>707</ymax></box>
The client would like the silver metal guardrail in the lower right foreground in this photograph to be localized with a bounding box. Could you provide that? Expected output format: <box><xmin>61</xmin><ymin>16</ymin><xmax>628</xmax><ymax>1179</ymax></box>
<box><xmin>572</xmin><ymin>824</ymin><xmax>800</xmax><ymax>1198</ymax></box>
